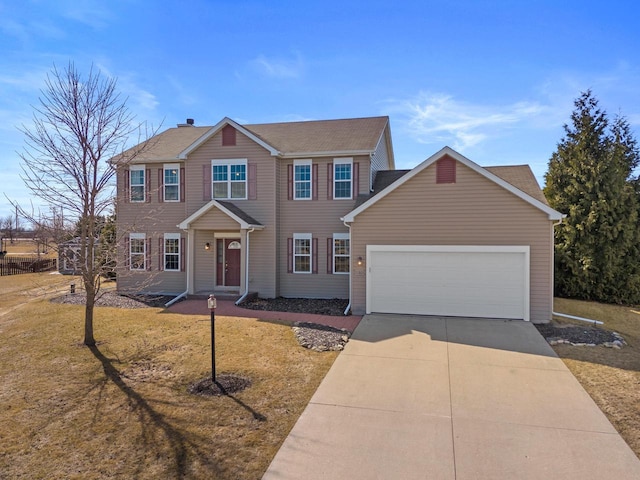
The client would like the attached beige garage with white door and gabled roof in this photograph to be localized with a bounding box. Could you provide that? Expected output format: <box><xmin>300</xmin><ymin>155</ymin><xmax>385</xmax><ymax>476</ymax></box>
<box><xmin>342</xmin><ymin>147</ymin><xmax>563</xmax><ymax>323</ymax></box>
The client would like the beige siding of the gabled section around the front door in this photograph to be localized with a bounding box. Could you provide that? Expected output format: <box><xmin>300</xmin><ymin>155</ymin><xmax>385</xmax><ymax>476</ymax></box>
<box><xmin>183</xmin><ymin>132</ymin><xmax>276</xmax><ymax>298</ymax></box>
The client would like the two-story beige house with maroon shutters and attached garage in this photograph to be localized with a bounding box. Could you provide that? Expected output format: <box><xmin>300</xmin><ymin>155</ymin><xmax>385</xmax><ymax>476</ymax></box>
<box><xmin>114</xmin><ymin>117</ymin><xmax>562</xmax><ymax>322</ymax></box>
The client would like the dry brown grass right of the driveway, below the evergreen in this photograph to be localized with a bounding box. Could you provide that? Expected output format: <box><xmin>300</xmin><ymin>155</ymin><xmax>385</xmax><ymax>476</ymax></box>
<box><xmin>553</xmin><ymin>298</ymin><xmax>640</xmax><ymax>458</ymax></box>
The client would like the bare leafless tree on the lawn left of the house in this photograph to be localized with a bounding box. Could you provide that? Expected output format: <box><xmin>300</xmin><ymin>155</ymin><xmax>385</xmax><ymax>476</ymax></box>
<box><xmin>20</xmin><ymin>63</ymin><xmax>149</xmax><ymax>346</ymax></box>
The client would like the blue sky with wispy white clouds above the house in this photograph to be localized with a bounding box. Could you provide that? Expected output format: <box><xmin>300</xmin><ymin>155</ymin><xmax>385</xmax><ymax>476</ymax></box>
<box><xmin>0</xmin><ymin>0</ymin><xmax>640</xmax><ymax>221</ymax></box>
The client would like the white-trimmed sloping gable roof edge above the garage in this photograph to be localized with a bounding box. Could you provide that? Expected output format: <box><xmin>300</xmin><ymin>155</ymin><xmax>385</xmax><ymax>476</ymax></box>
<box><xmin>342</xmin><ymin>147</ymin><xmax>563</xmax><ymax>222</ymax></box>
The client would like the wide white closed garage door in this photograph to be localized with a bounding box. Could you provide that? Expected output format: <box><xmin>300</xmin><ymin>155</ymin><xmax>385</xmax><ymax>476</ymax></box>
<box><xmin>367</xmin><ymin>245</ymin><xmax>529</xmax><ymax>320</ymax></box>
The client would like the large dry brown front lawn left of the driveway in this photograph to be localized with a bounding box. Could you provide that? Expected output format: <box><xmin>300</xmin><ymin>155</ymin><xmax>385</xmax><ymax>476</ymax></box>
<box><xmin>0</xmin><ymin>274</ymin><xmax>336</xmax><ymax>479</ymax></box>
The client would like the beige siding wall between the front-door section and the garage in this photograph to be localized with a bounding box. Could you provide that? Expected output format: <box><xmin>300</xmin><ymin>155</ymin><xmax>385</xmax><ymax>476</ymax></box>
<box><xmin>277</xmin><ymin>156</ymin><xmax>369</xmax><ymax>298</ymax></box>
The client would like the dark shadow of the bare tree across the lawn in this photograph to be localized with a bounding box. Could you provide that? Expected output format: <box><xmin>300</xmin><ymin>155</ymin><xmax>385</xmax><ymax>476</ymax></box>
<box><xmin>88</xmin><ymin>346</ymin><xmax>220</xmax><ymax>478</ymax></box>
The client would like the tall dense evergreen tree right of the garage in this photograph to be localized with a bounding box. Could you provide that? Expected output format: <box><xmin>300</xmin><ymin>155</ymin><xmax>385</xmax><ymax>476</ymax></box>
<box><xmin>544</xmin><ymin>91</ymin><xmax>640</xmax><ymax>303</ymax></box>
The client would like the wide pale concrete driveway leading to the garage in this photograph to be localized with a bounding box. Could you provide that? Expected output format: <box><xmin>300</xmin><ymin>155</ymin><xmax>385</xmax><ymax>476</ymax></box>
<box><xmin>263</xmin><ymin>315</ymin><xmax>640</xmax><ymax>480</ymax></box>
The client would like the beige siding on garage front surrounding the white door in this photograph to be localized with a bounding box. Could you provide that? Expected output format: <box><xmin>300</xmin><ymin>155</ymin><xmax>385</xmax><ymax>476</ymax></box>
<box><xmin>351</xmin><ymin>163</ymin><xmax>553</xmax><ymax>322</ymax></box>
